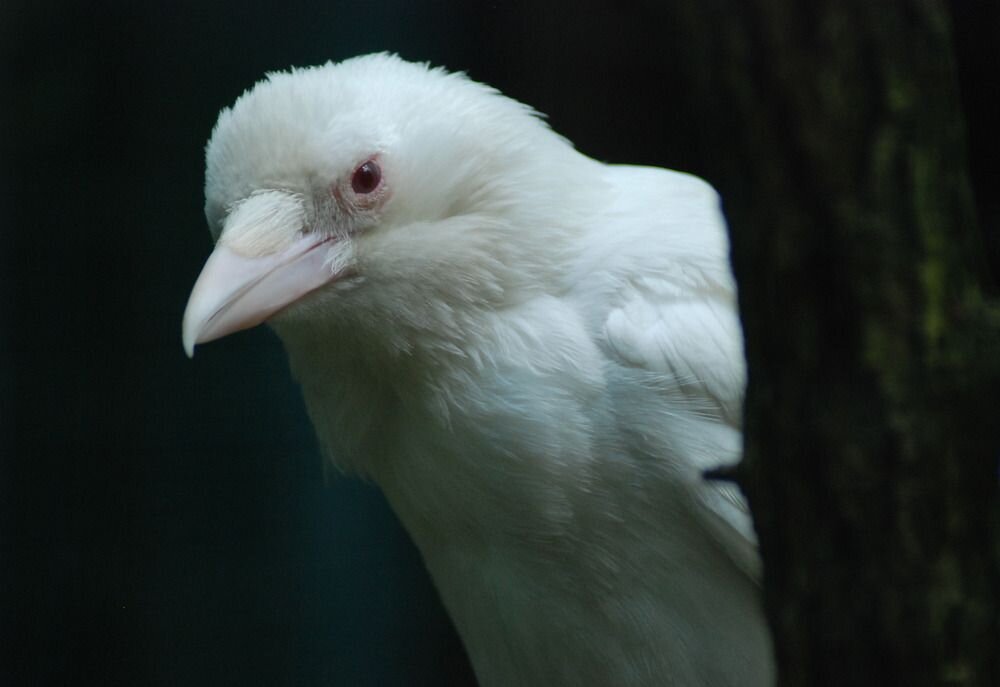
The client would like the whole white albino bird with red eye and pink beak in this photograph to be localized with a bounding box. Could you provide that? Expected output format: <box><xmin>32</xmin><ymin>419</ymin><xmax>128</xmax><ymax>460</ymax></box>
<box><xmin>183</xmin><ymin>54</ymin><xmax>774</xmax><ymax>687</ymax></box>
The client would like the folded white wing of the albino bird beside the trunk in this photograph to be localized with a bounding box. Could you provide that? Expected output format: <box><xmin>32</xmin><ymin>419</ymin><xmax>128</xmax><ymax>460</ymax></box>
<box><xmin>603</xmin><ymin>168</ymin><xmax>760</xmax><ymax>579</ymax></box>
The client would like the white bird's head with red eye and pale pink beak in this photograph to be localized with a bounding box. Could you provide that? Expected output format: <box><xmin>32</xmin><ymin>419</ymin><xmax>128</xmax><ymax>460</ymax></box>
<box><xmin>183</xmin><ymin>54</ymin><xmax>588</xmax><ymax>356</ymax></box>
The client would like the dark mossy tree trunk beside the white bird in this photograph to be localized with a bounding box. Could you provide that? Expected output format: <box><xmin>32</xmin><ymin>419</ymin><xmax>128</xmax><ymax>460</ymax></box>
<box><xmin>668</xmin><ymin>0</ymin><xmax>1000</xmax><ymax>686</ymax></box>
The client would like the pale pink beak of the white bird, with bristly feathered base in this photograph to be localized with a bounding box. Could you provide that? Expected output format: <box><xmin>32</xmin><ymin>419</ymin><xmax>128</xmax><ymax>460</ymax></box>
<box><xmin>182</xmin><ymin>197</ymin><xmax>338</xmax><ymax>358</ymax></box>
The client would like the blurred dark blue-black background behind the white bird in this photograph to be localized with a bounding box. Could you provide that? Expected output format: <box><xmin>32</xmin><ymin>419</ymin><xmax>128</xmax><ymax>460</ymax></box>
<box><xmin>0</xmin><ymin>0</ymin><xmax>1000</xmax><ymax>685</ymax></box>
